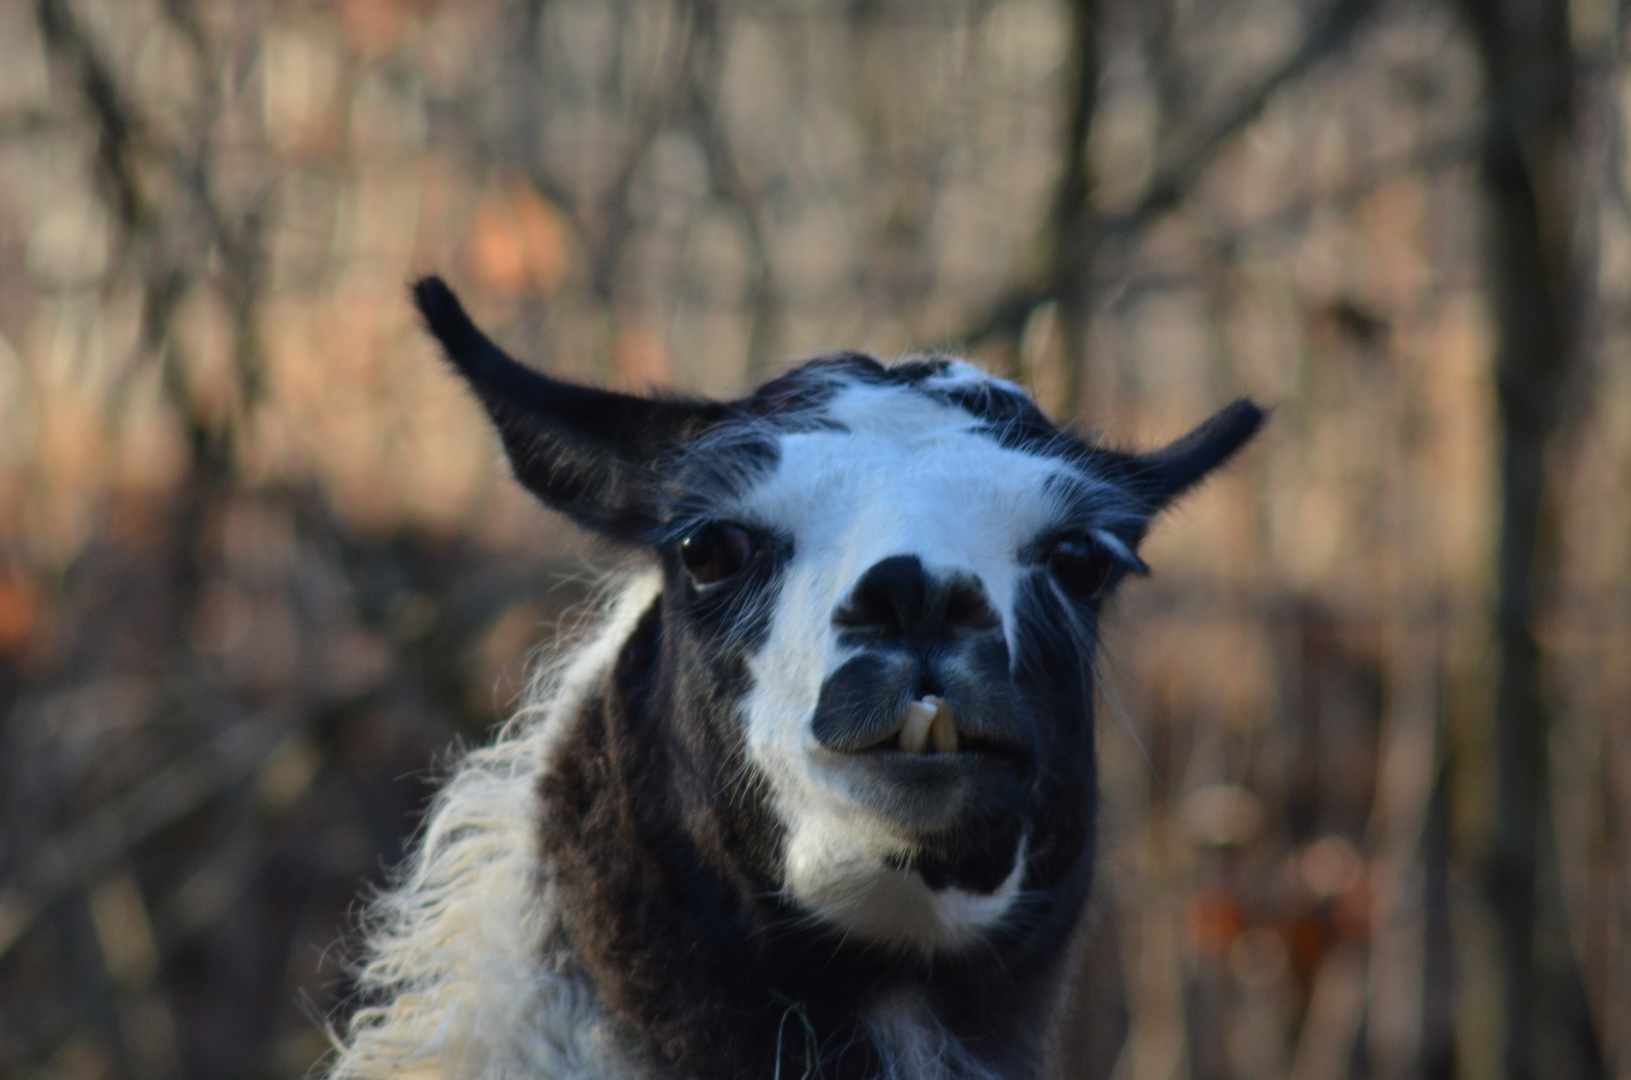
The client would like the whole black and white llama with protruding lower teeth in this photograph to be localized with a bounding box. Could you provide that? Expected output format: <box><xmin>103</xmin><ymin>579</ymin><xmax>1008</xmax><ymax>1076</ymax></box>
<box><xmin>329</xmin><ymin>279</ymin><xmax>1262</xmax><ymax>1080</ymax></box>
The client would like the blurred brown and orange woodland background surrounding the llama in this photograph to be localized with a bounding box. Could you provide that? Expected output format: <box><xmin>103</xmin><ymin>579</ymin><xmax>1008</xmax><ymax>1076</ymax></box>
<box><xmin>0</xmin><ymin>0</ymin><xmax>1631</xmax><ymax>1080</ymax></box>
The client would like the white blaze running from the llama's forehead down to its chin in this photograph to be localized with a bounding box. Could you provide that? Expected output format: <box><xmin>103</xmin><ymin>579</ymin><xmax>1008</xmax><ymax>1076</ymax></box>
<box><xmin>742</xmin><ymin>371</ymin><xmax>1080</xmax><ymax>949</ymax></box>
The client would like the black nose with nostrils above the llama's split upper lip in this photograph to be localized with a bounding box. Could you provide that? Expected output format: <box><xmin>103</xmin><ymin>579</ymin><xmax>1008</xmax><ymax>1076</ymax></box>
<box><xmin>833</xmin><ymin>555</ymin><xmax>1001</xmax><ymax>641</ymax></box>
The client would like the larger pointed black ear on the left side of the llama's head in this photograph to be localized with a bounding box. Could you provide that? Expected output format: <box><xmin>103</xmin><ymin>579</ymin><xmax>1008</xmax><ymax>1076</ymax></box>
<box><xmin>413</xmin><ymin>277</ymin><xmax>726</xmax><ymax>542</ymax></box>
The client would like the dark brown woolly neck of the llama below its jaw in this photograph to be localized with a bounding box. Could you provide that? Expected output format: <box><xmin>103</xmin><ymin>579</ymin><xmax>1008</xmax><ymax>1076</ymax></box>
<box><xmin>540</xmin><ymin>613</ymin><xmax>1070</xmax><ymax>1080</ymax></box>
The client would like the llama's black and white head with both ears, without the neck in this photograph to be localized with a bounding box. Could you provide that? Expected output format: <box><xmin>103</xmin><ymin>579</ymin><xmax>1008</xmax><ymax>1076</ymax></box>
<box><xmin>416</xmin><ymin>279</ymin><xmax>1262</xmax><ymax>954</ymax></box>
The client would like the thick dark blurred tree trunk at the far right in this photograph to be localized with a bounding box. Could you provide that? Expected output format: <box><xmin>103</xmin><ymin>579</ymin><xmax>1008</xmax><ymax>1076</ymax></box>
<box><xmin>1460</xmin><ymin>0</ymin><xmax>1592</xmax><ymax>1080</ymax></box>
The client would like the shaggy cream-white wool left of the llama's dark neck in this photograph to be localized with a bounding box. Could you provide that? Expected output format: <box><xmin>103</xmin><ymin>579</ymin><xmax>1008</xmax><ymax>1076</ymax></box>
<box><xmin>328</xmin><ymin>573</ymin><xmax>661</xmax><ymax>1080</ymax></box>
